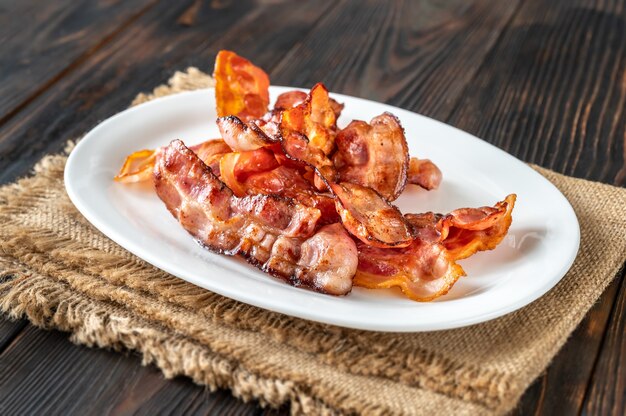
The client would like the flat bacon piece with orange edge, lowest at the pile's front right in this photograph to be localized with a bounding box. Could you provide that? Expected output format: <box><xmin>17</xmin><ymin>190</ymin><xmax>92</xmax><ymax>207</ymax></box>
<box><xmin>354</xmin><ymin>239</ymin><xmax>465</xmax><ymax>302</ymax></box>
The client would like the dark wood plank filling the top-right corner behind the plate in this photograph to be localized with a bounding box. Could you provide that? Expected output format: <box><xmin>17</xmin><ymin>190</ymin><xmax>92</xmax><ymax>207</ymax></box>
<box><xmin>450</xmin><ymin>0</ymin><xmax>626</xmax><ymax>185</ymax></box>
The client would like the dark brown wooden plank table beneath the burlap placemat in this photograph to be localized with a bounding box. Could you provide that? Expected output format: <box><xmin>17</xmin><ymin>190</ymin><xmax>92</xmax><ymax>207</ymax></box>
<box><xmin>0</xmin><ymin>0</ymin><xmax>626</xmax><ymax>415</ymax></box>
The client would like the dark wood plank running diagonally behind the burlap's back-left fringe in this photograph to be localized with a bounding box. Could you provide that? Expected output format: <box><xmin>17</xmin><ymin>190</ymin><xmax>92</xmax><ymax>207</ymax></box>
<box><xmin>0</xmin><ymin>0</ymin><xmax>333</xmax><ymax>183</ymax></box>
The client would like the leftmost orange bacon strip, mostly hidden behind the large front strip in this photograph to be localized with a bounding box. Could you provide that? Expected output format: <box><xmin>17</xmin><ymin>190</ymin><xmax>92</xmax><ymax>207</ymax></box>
<box><xmin>114</xmin><ymin>139</ymin><xmax>231</xmax><ymax>183</ymax></box>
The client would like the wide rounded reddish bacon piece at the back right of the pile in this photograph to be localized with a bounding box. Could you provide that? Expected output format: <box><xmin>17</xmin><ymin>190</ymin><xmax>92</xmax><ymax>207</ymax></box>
<box><xmin>333</xmin><ymin>113</ymin><xmax>409</xmax><ymax>201</ymax></box>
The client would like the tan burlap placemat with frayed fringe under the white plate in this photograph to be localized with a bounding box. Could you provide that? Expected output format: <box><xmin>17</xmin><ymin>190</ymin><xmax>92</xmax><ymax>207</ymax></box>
<box><xmin>0</xmin><ymin>69</ymin><xmax>626</xmax><ymax>414</ymax></box>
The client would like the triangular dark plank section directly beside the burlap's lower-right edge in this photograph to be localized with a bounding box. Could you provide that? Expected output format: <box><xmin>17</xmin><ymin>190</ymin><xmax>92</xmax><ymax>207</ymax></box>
<box><xmin>513</xmin><ymin>272</ymin><xmax>621</xmax><ymax>416</ymax></box>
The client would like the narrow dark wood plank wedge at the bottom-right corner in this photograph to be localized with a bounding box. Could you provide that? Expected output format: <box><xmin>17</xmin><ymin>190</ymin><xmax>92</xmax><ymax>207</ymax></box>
<box><xmin>583</xmin><ymin>276</ymin><xmax>626</xmax><ymax>415</ymax></box>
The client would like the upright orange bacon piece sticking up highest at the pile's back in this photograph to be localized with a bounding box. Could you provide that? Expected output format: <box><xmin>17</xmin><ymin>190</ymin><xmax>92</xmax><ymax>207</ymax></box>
<box><xmin>213</xmin><ymin>50</ymin><xmax>270</xmax><ymax>122</ymax></box>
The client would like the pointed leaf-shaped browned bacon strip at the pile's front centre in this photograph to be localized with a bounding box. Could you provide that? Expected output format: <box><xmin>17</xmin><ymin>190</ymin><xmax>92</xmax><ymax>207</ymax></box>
<box><xmin>330</xmin><ymin>182</ymin><xmax>413</xmax><ymax>248</ymax></box>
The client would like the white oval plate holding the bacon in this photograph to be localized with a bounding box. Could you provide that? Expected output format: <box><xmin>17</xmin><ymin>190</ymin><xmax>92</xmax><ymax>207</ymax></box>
<box><xmin>65</xmin><ymin>87</ymin><xmax>580</xmax><ymax>331</ymax></box>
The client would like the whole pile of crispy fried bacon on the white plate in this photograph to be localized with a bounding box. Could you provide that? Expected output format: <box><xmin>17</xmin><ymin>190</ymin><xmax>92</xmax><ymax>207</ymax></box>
<box><xmin>115</xmin><ymin>51</ymin><xmax>515</xmax><ymax>301</ymax></box>
